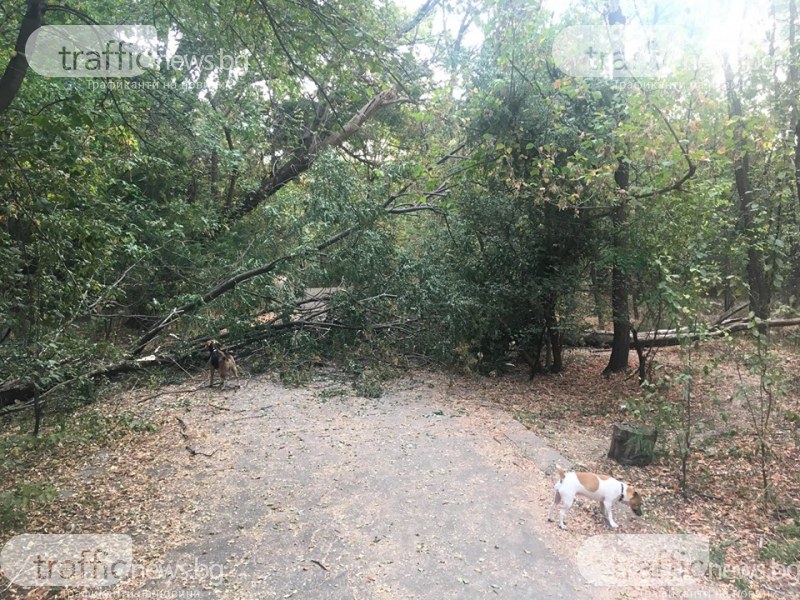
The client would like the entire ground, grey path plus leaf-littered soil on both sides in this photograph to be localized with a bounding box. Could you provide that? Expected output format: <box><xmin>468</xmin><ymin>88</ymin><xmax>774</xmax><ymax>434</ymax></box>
<box><xmin>0</xmin><ymin>340</ymin><xmax>800</xmax><ymax>600</ymax></box>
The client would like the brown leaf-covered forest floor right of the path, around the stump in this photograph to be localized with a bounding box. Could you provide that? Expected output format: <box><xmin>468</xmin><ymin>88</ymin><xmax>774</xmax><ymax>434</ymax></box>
<box><xmin>510</xmin><ymin>340</ymin><xmax>800</xmax><ymax>598</ymax></box>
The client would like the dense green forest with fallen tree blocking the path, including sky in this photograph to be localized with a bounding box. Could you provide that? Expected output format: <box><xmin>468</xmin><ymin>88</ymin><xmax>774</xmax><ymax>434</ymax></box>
<box><xmin>0</xmin><ymin>0</ymin><xmax>800</xmax><ymax>592</ymax></box>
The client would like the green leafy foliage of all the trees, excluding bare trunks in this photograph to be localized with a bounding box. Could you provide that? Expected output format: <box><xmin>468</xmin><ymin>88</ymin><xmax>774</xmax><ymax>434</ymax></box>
<box><xmin>0</xmin><ymin>0</ymin><xmax>800</xmax><ymax>436</ymax></box>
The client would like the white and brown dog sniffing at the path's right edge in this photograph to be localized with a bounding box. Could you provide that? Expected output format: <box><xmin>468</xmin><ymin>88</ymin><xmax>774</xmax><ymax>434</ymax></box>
<box><xmin>547</xmin><ymin>466</ymin><xmax>642</xmax><ymax>529</ymax></box>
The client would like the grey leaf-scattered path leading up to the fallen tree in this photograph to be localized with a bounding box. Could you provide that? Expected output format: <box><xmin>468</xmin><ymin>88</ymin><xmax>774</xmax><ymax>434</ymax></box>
<box><xmin>115</xmin><ymin>376</ymin><xmax>736</xmax><ymax>600</ymax></box>
